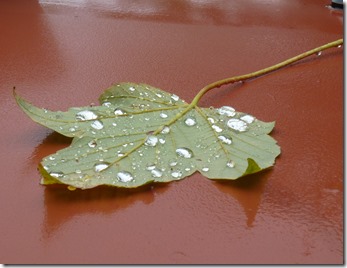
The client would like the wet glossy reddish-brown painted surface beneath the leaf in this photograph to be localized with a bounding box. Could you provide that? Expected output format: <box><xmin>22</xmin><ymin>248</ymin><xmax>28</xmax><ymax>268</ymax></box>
<box><xmin>0</xmin><ymin>0</ymin><xmax>343</xmax><ymax>264</ymax></box>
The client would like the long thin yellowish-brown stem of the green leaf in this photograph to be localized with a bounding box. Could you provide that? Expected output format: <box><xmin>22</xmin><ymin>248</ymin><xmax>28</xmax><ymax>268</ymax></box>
<box><xmin>189</xmin><ymin>39</ymin><xmax>343</xmax><ymax>108</ymax></box>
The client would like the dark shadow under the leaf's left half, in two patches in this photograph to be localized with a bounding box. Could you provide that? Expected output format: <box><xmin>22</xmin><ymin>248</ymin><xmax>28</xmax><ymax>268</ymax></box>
<box><xmin>31</xmin><ymin>132</ymin><xmax>169</xmax><ymax>239</ymax></box>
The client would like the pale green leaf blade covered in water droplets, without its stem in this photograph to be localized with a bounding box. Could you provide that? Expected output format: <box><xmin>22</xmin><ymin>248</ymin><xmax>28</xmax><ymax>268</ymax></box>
<box><xmin>15</xmin><ymin>83</ymin><xmax>280</xmax><ymax>189</ymax></box>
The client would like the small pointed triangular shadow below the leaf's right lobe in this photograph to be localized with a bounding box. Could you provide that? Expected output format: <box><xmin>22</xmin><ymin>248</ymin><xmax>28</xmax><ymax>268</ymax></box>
<box><xmin>213</xmin><ymin>169</ymin><xmax>272</xmax><ymax>228</ymax></box>
